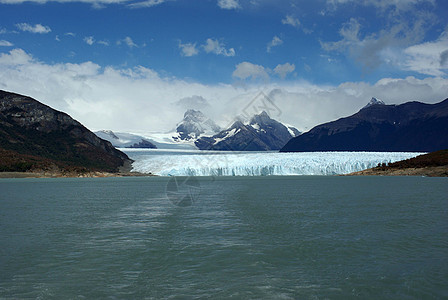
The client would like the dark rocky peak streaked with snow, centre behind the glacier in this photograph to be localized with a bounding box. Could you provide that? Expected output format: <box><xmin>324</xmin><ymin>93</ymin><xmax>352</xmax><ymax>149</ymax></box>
<box><xmin>195</xmin><ymin>111</ymin><xmax>299</xmax><ymax>151</ymax></box>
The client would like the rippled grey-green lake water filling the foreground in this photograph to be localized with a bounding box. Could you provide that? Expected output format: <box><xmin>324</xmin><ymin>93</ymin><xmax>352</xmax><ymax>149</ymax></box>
<box><xmin>0</xmin><ymin>176</ymin><xmax>448</xmax><ymax>299</ymax></box>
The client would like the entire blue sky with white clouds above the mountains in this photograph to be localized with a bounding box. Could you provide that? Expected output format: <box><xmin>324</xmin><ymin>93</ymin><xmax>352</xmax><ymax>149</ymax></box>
<box><xmin>0</xmin><ymin>0</ymin><xmax>448</xmax><ymax>133</ymax></box>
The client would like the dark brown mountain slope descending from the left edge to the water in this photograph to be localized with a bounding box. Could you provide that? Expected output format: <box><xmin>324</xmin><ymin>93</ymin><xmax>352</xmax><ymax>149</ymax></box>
<box><xmin>0</xmin><ymin>90</ymin><xmax>129</xmax><ymax>172</ymax></box>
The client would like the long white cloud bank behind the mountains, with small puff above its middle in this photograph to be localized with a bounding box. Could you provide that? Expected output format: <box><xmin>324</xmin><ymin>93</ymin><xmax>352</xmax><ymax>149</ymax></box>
<box><xmin>0</xmin><ymin>49</ymin><xmax>448</xmax><ymax>133</ymax></box>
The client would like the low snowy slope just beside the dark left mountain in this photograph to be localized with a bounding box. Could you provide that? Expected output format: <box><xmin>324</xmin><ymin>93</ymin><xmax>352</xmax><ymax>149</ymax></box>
<box><xmin>95</xmin><ymin>130</ymin><xmax>157</xmax><ymax>149</ymax></box>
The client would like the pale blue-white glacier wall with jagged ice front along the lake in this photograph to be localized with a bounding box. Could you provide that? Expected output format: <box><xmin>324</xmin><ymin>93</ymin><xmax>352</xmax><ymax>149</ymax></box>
<box><xmin>123</xmin><ymin>149</ymin><xmax>423</xmax><ymax>176</ymax></box>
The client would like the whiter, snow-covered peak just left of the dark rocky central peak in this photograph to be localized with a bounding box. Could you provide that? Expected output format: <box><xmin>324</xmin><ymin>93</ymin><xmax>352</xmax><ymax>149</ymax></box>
<box><xmin>173</xmin><ymin>109</ymin><xmax>221</xmax><ymax>141</ymax></box>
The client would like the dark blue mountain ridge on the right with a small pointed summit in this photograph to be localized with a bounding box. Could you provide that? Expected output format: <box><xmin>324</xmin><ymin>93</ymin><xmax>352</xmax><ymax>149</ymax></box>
<box><xmin>280</xmin><ymin>98</ymin><xmax>448</xmax><ymax>152</ymax></box>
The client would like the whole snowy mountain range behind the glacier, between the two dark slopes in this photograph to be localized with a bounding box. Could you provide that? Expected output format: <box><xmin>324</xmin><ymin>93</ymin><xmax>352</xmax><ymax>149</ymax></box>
<box><xmin>95</xmin><ymin>109</ymin><xmax>300</xmax><ymax>151</ymax></box>
